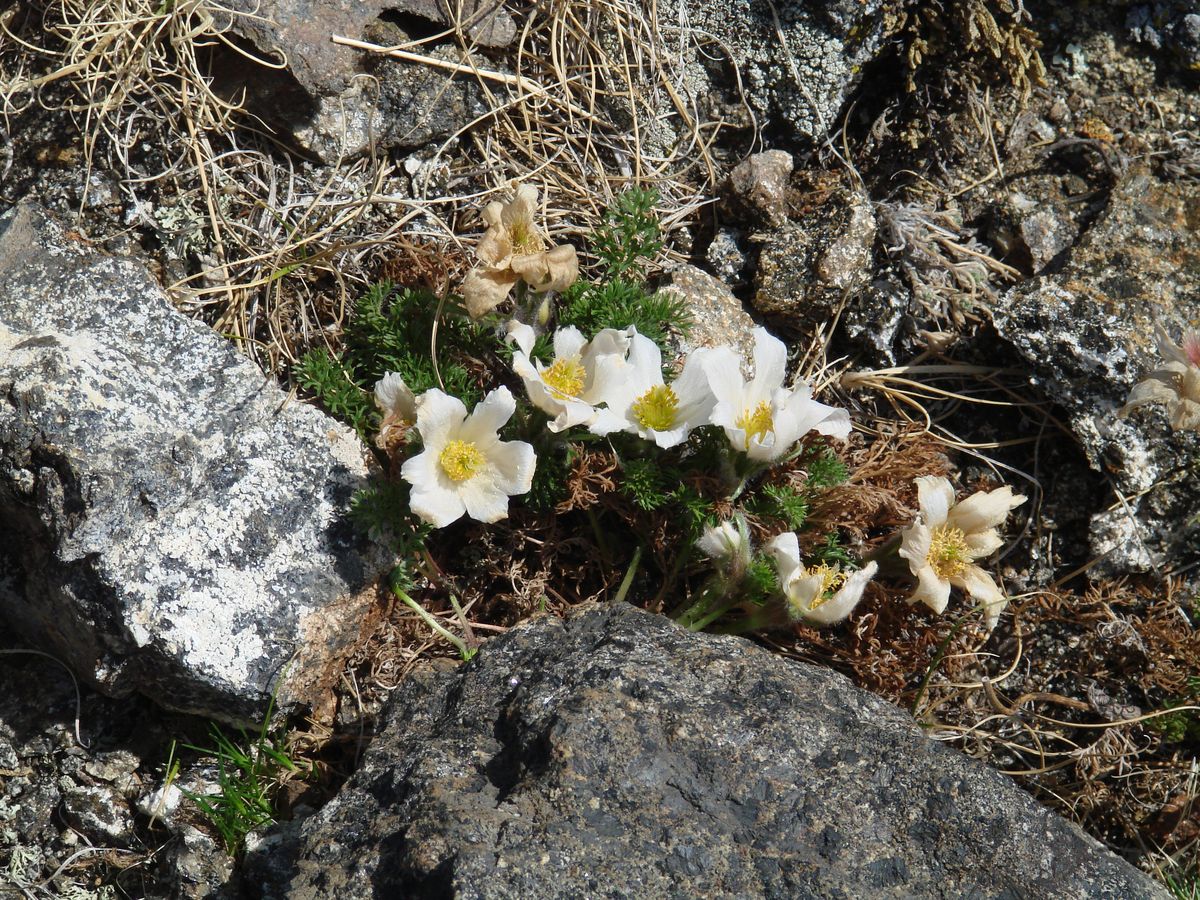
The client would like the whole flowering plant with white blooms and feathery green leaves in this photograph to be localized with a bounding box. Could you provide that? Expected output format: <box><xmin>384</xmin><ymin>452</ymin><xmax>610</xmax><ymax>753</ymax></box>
<box><xmin>312</xmin><ymin>185</ymin><xmax>1032</xmax><ymax>652</ymax></box>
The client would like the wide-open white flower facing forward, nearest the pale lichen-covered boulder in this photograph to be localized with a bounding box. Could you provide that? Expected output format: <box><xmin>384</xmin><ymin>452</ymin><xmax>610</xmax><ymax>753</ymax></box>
<box><xmin>400</xmin><ymin>388</ymin><xmax>536</xmax><ymax>528</ymax></box>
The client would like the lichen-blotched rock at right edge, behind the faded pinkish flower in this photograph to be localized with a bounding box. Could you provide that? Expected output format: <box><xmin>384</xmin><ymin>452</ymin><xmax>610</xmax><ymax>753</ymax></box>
<box><xmin>995</xmin><ymin>172</ymin><xmax>1200</xmax><ymax>574</ymax></box>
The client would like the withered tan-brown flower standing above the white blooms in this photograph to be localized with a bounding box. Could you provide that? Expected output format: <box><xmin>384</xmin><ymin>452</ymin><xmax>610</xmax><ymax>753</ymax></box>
<box><xmin>462</xmin><ymin>185</ymin><xmax>580</xmax><ymax>319</ymax></box>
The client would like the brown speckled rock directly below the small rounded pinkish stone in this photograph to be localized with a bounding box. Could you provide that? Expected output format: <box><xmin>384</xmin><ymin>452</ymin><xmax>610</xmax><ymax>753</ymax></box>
<box><xmin>752</xmin><ymin>188</ymin><xmax>875</xmax><ymax>332</ymax></box>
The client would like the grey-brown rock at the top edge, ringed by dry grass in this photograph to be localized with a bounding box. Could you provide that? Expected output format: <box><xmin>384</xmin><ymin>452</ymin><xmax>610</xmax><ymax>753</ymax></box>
<box><xmin>216</xmin><ymin>0</ymin><xmax>516</xmax><ymax>163</ymax></box>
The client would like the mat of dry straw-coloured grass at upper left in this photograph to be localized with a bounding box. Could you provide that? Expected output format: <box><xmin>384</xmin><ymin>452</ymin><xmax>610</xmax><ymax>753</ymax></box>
<box><xmin>0</xmin><ymin>0</ymin><xmax>722</xmax><ymax>373</ymax></box>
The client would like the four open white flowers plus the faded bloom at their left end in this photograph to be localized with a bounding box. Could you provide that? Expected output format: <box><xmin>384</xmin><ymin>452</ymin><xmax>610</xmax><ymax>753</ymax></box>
<box><xmin>376</xmin><ymin>322</ymin><xmax>850</xmax><ymax>528</ymax></box>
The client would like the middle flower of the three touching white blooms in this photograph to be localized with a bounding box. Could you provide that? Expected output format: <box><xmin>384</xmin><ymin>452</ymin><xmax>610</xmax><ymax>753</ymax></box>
<box><xmin>589</xmin><ymin>326</ymin><xmax>716</xmax><ymax>449</ymax></box>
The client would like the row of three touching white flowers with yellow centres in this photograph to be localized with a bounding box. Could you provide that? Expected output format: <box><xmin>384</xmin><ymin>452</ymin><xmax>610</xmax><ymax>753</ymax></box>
<box><xmin>509</xmin><ymin>323</ymin><xmax>850</xmax><ymax>463</ymax></box>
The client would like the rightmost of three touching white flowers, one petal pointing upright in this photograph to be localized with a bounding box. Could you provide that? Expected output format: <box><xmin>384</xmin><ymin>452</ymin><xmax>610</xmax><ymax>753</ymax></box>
<box><xmin>704</xmin><ymin>328</ymin><xmax>850</xmax><ymax>462</ymax></box>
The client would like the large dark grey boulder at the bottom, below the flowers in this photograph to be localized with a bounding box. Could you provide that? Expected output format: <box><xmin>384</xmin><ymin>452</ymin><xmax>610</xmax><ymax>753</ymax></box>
<box><xmin>246</xmin><ymin>605</ymin><xmax>1165</xmax><ymax>900</ymax></box>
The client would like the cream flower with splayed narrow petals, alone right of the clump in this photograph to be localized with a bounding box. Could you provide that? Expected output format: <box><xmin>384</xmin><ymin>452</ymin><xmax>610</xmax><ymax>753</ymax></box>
<box><xmin>900</xmin><ymin>475</ymin><xmax>1025</xmax><ymax>630</ymax></box>
